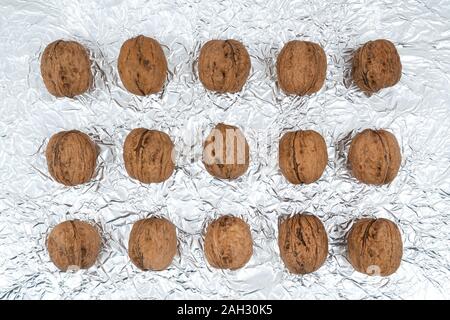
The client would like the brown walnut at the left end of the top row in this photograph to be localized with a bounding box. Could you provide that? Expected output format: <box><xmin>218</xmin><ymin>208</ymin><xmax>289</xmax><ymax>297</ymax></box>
<box><xmin>41</xmin><ymin>40</ymin><xmax>92</xmax><ymax>98</ymax></box>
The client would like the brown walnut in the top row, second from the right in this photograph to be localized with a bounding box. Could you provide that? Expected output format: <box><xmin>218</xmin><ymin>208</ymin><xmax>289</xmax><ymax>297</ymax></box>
<box><xmin>277</xmin><ymin>40</ymin><xmax>327</xmax><ymax>96</ymax></box>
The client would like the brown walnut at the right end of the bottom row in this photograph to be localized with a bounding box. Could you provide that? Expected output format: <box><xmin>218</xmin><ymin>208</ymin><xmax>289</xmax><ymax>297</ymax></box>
<box><xmin>347</xmin><ymin>219</ymin><xmax>403</xmax><ymax>276</ymax></box>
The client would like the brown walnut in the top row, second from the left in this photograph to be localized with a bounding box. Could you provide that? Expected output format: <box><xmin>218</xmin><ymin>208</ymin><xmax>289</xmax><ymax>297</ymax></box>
<box><xmin>118</xmin><ymin>35</ymin><xmax>167</xmax><ymax>96</ymax></box>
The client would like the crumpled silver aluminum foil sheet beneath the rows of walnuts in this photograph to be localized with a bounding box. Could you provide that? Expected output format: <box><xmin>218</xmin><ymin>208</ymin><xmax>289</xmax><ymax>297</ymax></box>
<box><xmin>0</xmin><ymin>0</ymin><xmax>450</xmax><ymax>299</ymax></box>
